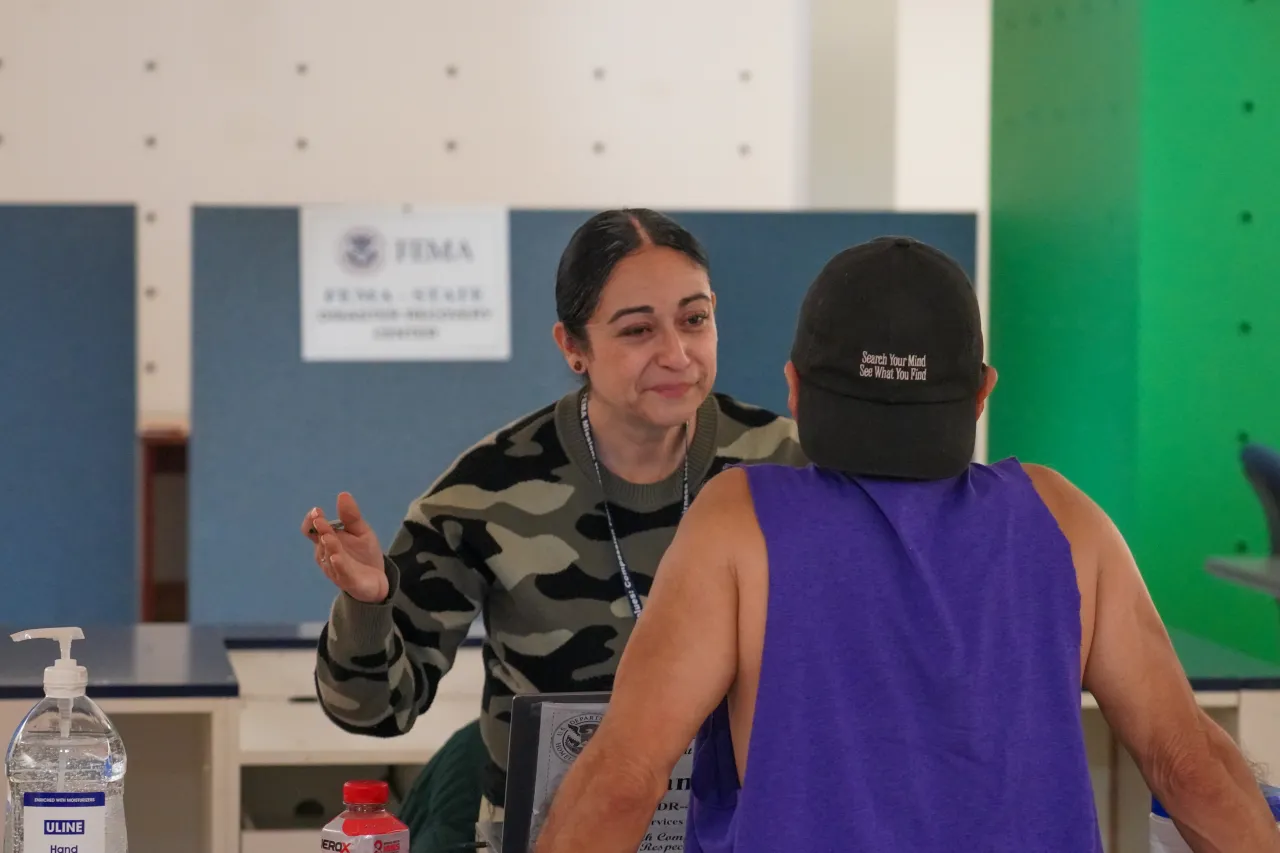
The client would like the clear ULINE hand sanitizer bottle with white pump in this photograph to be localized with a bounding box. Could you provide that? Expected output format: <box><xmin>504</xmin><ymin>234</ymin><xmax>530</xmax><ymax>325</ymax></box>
<box><xmin>4</xmin><ymin>628</ymin><xmax>129</xmax><ymax>853</ymax></box>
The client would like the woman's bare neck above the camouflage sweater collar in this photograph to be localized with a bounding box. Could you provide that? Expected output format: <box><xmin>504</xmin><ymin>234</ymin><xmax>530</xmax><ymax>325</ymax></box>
<box><xmin>586</xmin><ymin>396</ymin><xmax>696</xmax><ymax>485</ymax></box>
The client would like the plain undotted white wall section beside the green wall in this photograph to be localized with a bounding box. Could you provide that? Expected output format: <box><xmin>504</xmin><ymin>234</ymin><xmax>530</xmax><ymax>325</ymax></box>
<box><xmin>808</xmin><ymin>0</ymin><xmax>998</xmax><ymax>460</ymax></box>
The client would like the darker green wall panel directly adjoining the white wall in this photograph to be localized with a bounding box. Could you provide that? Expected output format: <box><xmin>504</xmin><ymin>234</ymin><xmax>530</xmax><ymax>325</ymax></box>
<box><xmin>988</xmin><ymin>0</ymin><xmax>1139</xmax><ymax>525</ymax></box>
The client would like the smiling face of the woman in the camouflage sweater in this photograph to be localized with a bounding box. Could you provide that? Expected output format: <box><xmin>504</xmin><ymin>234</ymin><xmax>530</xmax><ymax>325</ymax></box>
<box><xmin>557</xmin><ymin>246</ymin><xmax>716</xmax><ymax>427</ymax></box>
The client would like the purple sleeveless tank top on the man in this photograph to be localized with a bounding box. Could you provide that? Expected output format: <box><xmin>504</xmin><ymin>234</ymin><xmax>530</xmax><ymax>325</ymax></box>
<box><xmin>685</xmin><ymin>460</ymin><xmax>1102</xmax><ymax>853</ymax></box>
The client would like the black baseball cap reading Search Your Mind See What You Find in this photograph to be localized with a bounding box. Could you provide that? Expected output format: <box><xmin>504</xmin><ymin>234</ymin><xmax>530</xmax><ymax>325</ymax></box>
<box><xmin>791</xmin><ymin>237</ymin><xmax>983</xmax><ymax>480</ymax></box>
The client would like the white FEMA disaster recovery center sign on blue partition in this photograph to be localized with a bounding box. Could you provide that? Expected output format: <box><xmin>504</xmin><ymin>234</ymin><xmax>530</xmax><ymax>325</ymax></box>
<box><xmin>300</xmin><ymin>205</ymin><xmax>511</xmax><ymax>361</ymax></box>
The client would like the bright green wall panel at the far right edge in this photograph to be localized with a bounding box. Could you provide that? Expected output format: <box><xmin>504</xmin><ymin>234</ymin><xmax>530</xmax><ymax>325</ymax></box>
<box><xmin>1138</xmin><ymin>0</ymin><xmax>1280</xmax><ymax>650</ymax></box>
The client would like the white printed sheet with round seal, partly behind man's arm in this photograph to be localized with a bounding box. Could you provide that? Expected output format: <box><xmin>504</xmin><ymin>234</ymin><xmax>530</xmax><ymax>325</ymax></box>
<box><xmin>529</xmin><ymin>702</ymin><xmax>694</xmax><ymax>853</ymax></box>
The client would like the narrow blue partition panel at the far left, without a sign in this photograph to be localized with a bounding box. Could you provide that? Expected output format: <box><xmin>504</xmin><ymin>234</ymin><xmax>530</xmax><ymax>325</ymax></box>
<box><xmin>0</xmin><ymin>205</ymin><xmax>138</xmax><ymax>628</ymax></box>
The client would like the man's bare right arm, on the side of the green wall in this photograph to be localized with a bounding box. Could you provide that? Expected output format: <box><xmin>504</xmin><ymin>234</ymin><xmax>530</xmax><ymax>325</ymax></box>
<box><xmin>1033</xmin><ymin>469</ymin><xmax>1280</xmax><ymax>853</ymax></box>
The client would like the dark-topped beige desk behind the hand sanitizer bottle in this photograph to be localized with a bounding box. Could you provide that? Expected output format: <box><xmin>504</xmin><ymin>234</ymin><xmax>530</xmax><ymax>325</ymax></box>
<box><xmin>0</xmin><ymin>625</ymin><xmax>239</xmax><ymax>853</ymax></box>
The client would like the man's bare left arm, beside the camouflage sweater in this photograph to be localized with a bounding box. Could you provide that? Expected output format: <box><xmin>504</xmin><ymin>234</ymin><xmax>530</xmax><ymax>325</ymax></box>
<box><xmin>536</xmin><ymin>469</ymin><xmax>755</xmax><ymax>853</ymax></box>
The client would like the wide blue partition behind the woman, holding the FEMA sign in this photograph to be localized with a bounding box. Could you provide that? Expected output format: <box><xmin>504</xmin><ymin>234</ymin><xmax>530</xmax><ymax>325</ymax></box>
<box><xmin>188</xmin><ymin>207</ymin><xmax>977</xmax><ymax>622</ymax></box>
